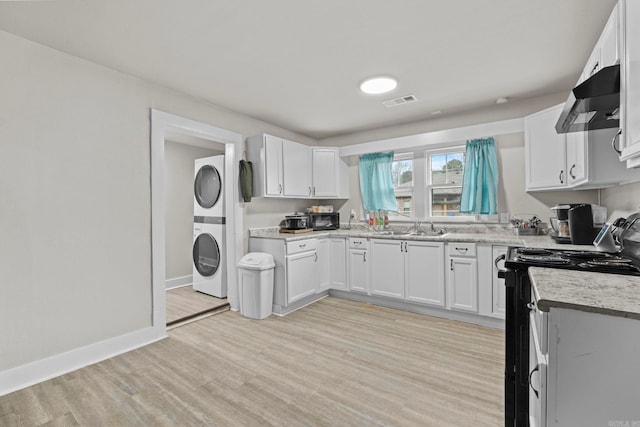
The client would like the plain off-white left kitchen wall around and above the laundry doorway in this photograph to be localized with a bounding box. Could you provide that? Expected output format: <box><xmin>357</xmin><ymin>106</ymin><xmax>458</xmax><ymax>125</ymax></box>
<box><xmin>0</xmin><ymin>31</ymin><xmax>314</xmax><ymax>378</ymax></box>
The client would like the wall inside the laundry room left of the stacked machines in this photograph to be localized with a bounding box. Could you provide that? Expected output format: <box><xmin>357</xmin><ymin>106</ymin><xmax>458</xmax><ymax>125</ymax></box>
<box><xmin>164</xmin><ymin>141</ymin><xmax>224</xmax><ymax>280</ymax></box>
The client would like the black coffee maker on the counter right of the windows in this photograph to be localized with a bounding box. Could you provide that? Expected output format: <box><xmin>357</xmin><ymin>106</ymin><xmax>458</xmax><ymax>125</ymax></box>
<box><xmin>550</xmin><ymin>203</ymin><xmax>607</xmax><ymax>245</ymax></box>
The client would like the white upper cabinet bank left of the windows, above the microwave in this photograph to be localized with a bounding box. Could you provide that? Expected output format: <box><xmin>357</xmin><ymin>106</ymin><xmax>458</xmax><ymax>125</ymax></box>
<box><xmin>247</xmin><ymin>134</ymin><xmax>349</xmax><ymax>199</ymax></box>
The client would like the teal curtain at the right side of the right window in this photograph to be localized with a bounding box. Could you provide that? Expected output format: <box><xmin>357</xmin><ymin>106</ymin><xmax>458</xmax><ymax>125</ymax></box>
<box><xmin>460</xmin><ymin>138</ymin><xmax>498</xmax><ymax>214</ymax></box>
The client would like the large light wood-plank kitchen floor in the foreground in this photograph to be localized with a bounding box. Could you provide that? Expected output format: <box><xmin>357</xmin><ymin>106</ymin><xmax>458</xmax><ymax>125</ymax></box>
<box><xmin>0</xmin><ymin>298</ymin><xmax>504</xmax><ymax>427</ymax></box>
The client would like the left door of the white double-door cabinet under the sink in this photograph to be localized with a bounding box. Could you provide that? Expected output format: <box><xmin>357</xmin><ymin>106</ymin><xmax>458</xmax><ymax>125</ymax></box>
<box><xmin>370</xmin><ymin>239</ymin><xmax>406</xmax><ymax>298</ymax></box>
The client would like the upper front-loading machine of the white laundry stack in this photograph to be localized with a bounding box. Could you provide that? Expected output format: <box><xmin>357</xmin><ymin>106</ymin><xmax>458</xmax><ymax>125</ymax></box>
<box><xmin>193</xmin><ymin>155</ymin><xmax>224</xmax><ymax>218</ymax></box>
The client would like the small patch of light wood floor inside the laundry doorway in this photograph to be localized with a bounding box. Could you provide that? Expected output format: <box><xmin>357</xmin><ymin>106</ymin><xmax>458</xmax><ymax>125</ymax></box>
<box><xmin>166</xmin><ymin>286</ymin><xmax>229</xmax><ymax>326</ymax></box>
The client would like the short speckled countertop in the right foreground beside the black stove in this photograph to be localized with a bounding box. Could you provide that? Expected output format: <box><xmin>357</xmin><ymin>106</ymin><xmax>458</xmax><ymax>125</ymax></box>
<box><xmin>529</xmin><ymin>267</ymin><xmax>640</xmax><ymax>320</ymax></box>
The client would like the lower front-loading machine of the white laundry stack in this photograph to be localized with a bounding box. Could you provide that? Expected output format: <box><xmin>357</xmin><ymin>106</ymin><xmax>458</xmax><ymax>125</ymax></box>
<box><xmin>193</xmin><ymin>223</ymin><xmax>227</xmax><ymax>298</ymax></box>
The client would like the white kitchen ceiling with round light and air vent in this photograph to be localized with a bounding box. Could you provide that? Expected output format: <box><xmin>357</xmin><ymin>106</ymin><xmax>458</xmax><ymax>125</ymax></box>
<box><xmin>0</xmin><ymin>0</ymin><xmax>616</xmax><ymax>139</ymax></box>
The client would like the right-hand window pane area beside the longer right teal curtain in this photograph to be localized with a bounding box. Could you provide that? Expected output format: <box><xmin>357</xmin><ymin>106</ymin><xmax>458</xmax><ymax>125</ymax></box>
<box><xmin>426</xmin><ymin>146</ymin><xmax>468</xmax><ymax>217</ymax></box>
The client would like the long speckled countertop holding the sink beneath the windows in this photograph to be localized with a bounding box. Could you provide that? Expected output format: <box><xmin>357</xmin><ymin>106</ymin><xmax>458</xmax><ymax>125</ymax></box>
<box><xmin>249</xmin><ymin>224</ymin><xmax>593</xmax><ymax>250</ymax></box>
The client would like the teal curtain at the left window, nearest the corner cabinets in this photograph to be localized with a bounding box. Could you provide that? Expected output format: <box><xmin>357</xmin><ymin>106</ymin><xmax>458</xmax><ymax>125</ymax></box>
<box><xmin>359</xmin><ymin>151</ymin><xmax>398</xmax><ymax>212</ymax></box>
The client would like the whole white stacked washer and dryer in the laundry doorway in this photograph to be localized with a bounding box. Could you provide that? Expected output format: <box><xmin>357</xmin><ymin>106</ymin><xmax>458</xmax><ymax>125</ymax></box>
<box><xmin>193</xmin><ymin>155</ymin><xmax>227</xmax><ymax>298</ymax></box>
